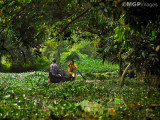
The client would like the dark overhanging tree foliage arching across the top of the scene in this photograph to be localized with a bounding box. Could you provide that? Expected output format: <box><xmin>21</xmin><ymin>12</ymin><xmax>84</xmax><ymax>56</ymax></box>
<box><xmin>0</xmin><ymin>0</ymin><xmax>160</xmax><ymax>74</ymax></box>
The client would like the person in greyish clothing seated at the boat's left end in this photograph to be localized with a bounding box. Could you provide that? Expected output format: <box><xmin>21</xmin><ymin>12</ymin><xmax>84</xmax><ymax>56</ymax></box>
<box><xmin>50</xmin><ymin>58</ymin><xmax>61</xmax><ymax>77</ymax></box>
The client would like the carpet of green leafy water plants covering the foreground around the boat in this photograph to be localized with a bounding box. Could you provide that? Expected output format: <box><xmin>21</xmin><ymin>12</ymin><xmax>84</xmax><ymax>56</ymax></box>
<box><xmin>0</xmin><ymin>72</ymin><xmax>160</xmax><ymax>120</ymax></box>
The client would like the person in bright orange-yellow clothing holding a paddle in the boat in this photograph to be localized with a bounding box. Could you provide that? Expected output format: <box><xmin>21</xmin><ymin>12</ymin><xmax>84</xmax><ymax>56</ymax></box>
<box><xmin>68</xmin><ymin>60</ymin><xmax>78</xmax><ymax>77</ymax></box>
